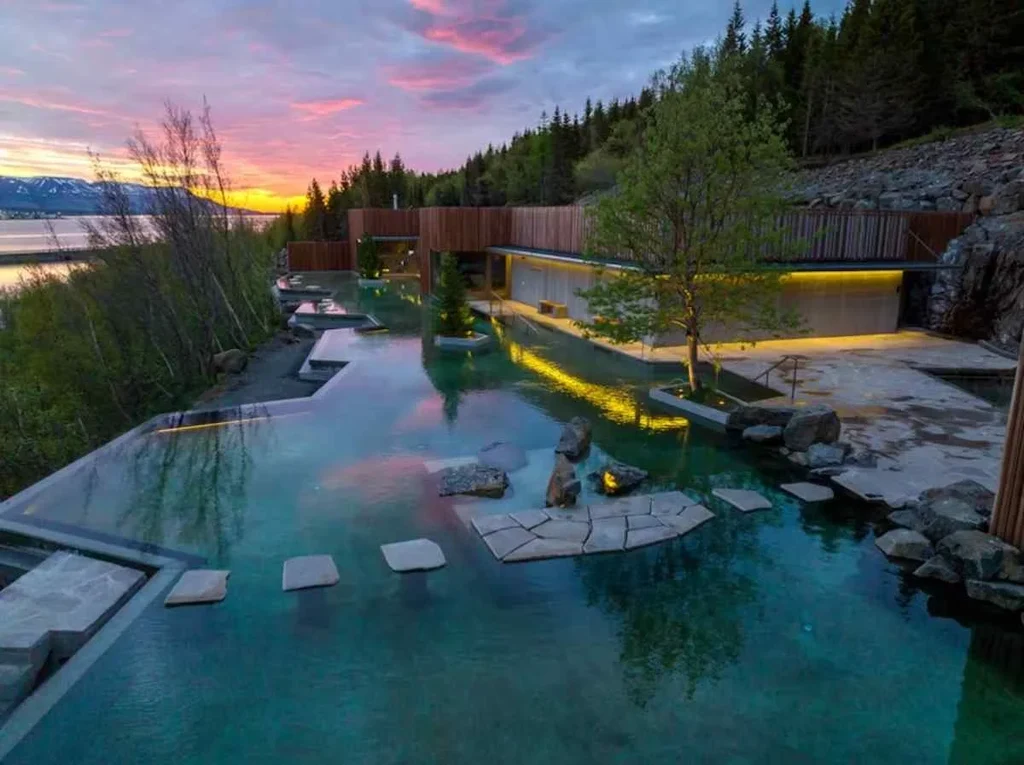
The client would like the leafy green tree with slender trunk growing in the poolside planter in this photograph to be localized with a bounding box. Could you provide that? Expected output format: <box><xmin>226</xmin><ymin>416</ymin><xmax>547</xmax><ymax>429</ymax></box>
<box><xmin>579</xmin><ymin>49</ymin><xmax>796</xmax><ymax>389</ymax></box>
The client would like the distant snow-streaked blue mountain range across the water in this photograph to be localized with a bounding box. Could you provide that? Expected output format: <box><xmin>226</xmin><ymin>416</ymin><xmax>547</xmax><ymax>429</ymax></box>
<box><xmin>0</xmin><ymin>175</ymin><xmax>254</xmax><ymax>215</ymax></box>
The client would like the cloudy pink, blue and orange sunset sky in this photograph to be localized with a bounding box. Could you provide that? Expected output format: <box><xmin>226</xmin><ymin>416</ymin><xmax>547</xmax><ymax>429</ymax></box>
<box><xmin>0</xmin><ymin>0</ymin><xmax>842</xmax><ymax>210</ymax></box>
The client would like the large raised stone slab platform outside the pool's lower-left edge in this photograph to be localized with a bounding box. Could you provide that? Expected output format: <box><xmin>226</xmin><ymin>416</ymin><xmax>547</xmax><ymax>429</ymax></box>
<box><xmin>0</xmin><ymin>552</ymin><xmax>145</xmax><ymax>668</ymax></box>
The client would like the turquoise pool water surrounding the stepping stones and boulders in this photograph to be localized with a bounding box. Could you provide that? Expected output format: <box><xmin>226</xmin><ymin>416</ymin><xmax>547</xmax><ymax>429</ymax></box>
<box><xmin>7</xmin><ymin>283</ymin><xmax>1024</xmax><ymax>765</ymax></box>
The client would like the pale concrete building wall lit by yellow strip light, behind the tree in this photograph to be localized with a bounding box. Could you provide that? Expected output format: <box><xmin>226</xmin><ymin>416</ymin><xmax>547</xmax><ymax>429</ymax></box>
<box><xmin>509</xmin><ymin>257</ymin><xmax>903</xmax><ymax>345</ymax></box>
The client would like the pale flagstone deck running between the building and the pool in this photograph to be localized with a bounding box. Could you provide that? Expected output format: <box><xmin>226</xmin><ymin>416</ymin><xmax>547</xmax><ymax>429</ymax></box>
<box><xmin>473</xmin><ymin>300</ymin><xmax>1017</xmax><ymax>507</ymax></box>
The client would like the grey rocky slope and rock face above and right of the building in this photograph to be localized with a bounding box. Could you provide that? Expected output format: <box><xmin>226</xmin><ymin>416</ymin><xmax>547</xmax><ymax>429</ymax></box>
<box><xmin>795</xmin><ymin>128</ymin><xmax>1024</xmax><ymax>352</ymax></box>
